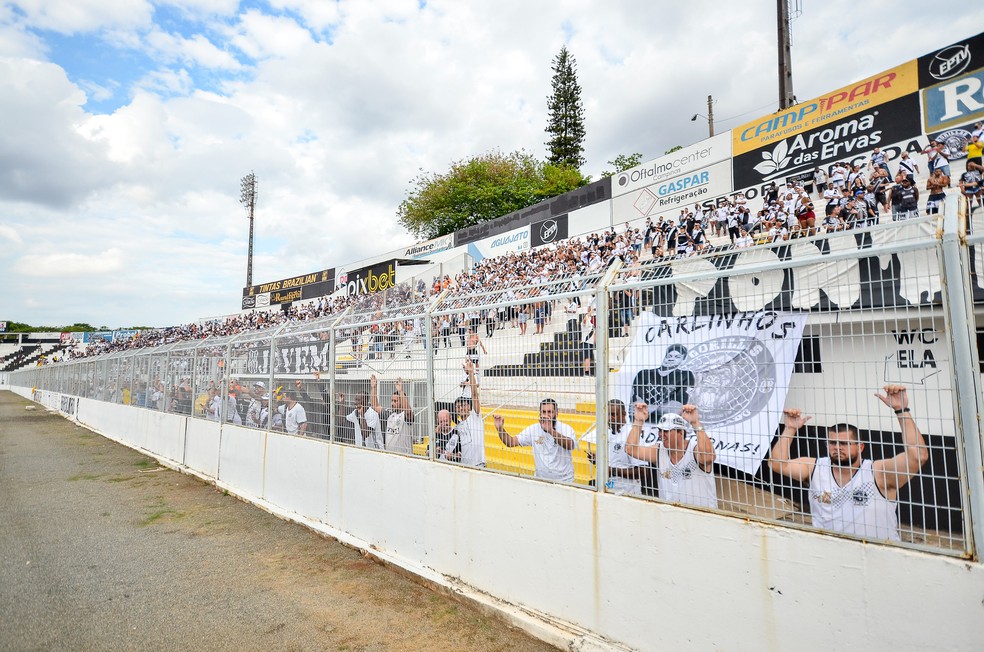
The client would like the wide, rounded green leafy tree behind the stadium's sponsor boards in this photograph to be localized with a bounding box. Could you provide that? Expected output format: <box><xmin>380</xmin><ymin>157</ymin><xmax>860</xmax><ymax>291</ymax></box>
<box><xmin>397</xmin><ymin>151</ymin><xmax>590</xmax><ymax>240</ymax></box>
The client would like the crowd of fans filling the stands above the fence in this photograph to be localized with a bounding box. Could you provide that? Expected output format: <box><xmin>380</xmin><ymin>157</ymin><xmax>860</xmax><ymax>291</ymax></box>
<box><xmin>42</xmin><ymin>131</ymin><xmax>984</xmax><ymax>360</ymax></box>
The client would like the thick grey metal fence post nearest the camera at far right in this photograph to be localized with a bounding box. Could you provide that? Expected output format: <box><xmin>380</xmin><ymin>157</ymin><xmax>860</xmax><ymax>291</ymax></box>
<box><xmin>941</xmin><ymin>195</ymin><xmax>984</xmax><ymax>557</ymax></box>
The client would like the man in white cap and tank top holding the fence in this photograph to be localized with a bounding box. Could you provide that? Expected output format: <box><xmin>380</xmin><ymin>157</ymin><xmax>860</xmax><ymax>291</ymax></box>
<box><xmin>625</xmin><ymin>402</ymin><xmax>717</xmax><ymax>509</ymax></box>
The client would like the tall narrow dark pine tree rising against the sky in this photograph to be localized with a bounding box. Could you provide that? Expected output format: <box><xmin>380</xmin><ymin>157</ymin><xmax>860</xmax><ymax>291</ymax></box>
<box><xmin>546</xmin><ymin>45</ymin><xmax>585</xmax><ymax>169</ymax></box>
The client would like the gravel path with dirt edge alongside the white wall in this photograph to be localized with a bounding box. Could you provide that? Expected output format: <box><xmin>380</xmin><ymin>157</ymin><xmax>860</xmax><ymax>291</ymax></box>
<box><xmin>0</xmin><ymin>392</ymin><xmax>554</xmax><ymax>652</ymax></box>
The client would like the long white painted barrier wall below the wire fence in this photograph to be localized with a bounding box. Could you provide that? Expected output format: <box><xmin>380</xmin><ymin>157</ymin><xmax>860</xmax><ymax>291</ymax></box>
<box><xmin>23</xmin><ymin>392</ymin><xmax>984</xmax><ymax>651</ymax></box>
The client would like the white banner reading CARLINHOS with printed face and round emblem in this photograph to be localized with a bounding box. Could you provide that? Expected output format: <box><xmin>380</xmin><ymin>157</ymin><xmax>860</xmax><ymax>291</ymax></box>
<box><xmin>612</xmin><ymin>311</ymin><xmax>807</xmax><ymax>474</ymax></box>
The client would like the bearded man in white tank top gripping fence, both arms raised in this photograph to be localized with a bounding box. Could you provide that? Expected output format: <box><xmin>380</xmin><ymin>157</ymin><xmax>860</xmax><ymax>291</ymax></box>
<box><xmin>769</xmin><ymin>385</ymin><xmax>929</xmax><ymax>541</ymax></box>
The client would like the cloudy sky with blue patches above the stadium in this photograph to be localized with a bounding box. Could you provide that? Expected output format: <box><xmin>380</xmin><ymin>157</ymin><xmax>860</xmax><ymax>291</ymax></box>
<box><xmin>0</xmin><ymin>0</ymin><xmax>984</xmax><ymax>327</ymax></box>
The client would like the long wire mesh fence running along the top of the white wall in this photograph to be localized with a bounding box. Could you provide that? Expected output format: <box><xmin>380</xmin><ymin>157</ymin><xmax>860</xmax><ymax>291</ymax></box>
<box><xmin>12</xmin><ymin>206</ymin><xmax>984</xmax><ymax>554</ymax></box>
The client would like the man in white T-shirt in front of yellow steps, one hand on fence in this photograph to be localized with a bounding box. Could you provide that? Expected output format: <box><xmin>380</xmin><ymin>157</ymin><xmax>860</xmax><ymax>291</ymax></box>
<box><xmin>492</xmin><ymin>398</ymin><xmax>577</xmax><ymax>482</ymax></box>
